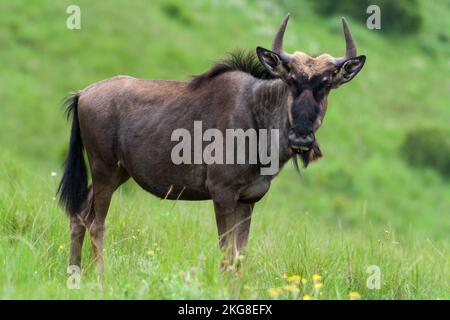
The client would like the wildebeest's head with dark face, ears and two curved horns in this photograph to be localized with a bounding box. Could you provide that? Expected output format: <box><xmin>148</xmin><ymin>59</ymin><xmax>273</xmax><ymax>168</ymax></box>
<box><xmin>256</xmin><ymin>14</ymin><xmax>366</xmax><ymax>159</ymax></box>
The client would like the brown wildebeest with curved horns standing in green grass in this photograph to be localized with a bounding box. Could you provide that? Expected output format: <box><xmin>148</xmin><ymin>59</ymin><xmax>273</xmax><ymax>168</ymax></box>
<box><xmin>59</xmin><ymin>15</ymin><xmax>365</xmax><ymax>276</ymax></box>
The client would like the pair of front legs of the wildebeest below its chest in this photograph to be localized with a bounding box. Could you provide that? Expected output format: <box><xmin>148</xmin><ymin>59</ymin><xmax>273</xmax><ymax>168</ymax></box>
<box><xmin>214</xmin><ymin>201</ymin><xmax>253</xmax><ymax>269</ymax></box>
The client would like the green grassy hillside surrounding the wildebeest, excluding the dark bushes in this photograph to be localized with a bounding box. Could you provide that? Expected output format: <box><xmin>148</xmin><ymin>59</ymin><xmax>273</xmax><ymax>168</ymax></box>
<box><xmin>0</xmin><ymin>0</ymin><xmax>450</xmax><ymax>299</ymax></box>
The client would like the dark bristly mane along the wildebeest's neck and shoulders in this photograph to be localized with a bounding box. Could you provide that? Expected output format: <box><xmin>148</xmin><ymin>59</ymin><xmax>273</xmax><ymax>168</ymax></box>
<box><xmin>189</xmin><ymin>50</ymin><xmax>275</xmax><ymax>89</ymax></box>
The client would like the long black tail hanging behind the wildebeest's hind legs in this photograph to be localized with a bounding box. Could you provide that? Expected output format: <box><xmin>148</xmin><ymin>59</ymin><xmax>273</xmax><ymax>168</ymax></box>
<box><xmin>58</xmin><ymin>94</ymin><xmax>88</xmax><ymax>215</ymax></box>
